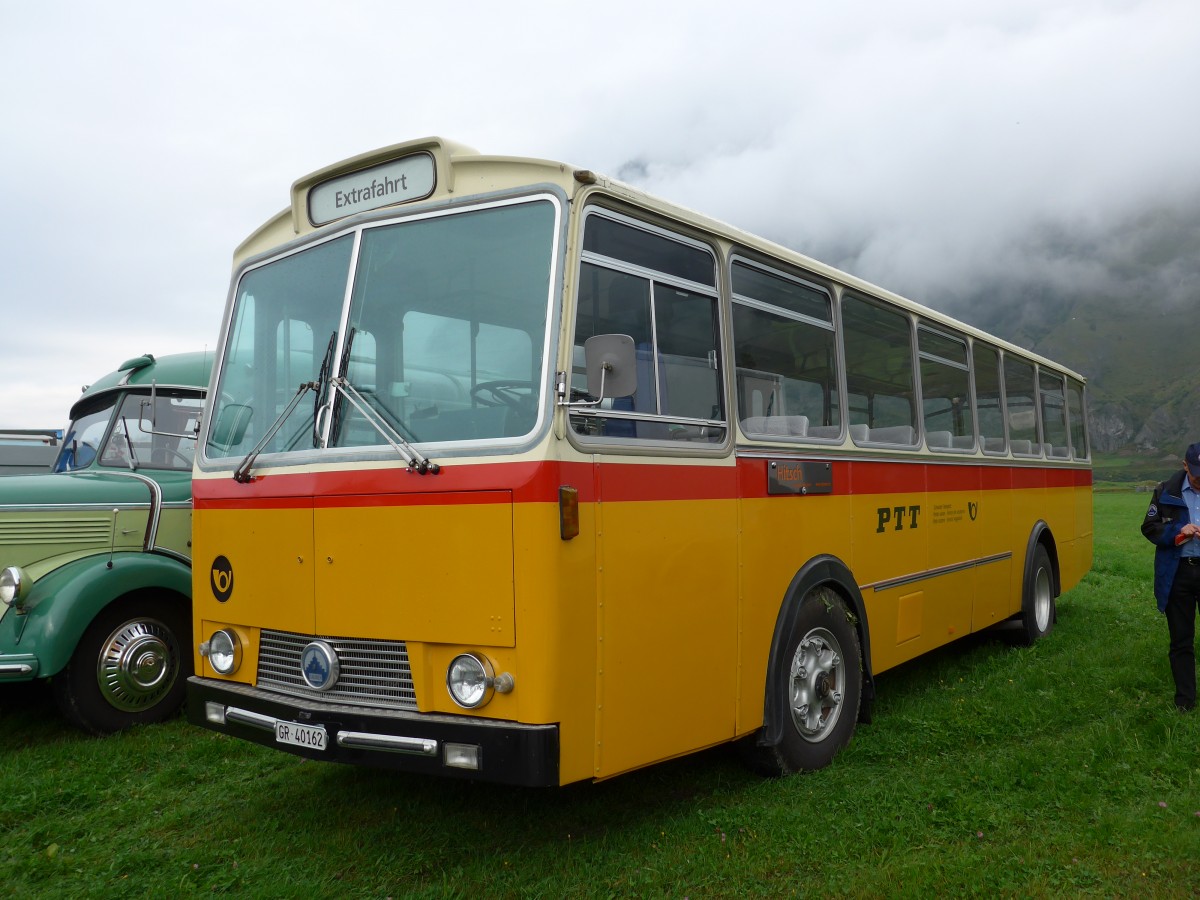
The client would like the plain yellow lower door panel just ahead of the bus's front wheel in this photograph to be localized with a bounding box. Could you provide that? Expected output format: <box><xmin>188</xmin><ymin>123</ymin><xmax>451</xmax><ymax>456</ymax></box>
<box><xmin>595</xmin><ymin>500</ymin><xmax>738</xmax><ymax>776</ymax></box>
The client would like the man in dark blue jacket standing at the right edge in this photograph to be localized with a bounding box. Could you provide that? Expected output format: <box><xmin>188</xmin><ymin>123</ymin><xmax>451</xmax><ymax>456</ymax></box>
<box><xmin>1141</xmin><ymin>443</ymin><xmax>1200</xmax><ymax>712</ymax></box>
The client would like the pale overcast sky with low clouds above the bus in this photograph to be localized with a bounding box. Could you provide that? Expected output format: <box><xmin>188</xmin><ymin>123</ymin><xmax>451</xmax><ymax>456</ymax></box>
<box><xmin>0</xmin><ymin>0</ymin><xmax>1200</xmax><ymax>430</ymax></box>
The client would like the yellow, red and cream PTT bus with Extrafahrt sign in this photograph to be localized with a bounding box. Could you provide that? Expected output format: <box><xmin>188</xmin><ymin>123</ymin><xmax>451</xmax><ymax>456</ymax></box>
<box><xmin>188</xmin><ymin>138</ymin><xmax>1092</xmax><ymax>785</ymax></box>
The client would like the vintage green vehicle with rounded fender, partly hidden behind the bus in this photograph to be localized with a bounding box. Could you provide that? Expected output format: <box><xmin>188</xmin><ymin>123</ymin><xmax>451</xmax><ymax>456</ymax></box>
<box><xmin>0</xmin><ymin>353</ymin><xmax>212</xmax><ymax>734</ymax></box>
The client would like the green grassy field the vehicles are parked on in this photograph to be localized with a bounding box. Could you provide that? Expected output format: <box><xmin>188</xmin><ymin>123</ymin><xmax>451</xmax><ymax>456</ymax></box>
<box><xmin>0</xmin><ymin>492</ymin><xmax>1200</xmax><ymax>898</ymax></box>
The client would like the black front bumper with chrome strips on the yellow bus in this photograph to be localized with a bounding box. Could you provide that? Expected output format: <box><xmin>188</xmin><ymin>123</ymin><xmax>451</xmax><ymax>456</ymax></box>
<box><xmin>187</xmin><ymin>676</ymin><xmax>558</xmax><ymax>787</ymax></box>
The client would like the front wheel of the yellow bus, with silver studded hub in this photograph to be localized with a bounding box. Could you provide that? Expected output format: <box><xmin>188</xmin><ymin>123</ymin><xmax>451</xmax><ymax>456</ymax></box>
<box><xmin>740</xmin><ymin>588</ymin><xmax>863</xmax><ymax>775</ymax></box>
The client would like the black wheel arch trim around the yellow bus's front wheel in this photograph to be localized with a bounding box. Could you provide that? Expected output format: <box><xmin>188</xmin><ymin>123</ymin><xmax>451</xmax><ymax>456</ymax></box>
<box><xmin>758</xmin><ymin>556</ymin><xmax>875</xmax><ymax>746</ymax></box>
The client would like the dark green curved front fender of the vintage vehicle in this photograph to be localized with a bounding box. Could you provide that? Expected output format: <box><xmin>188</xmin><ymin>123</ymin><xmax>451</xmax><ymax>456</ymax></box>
<box><xmin>4</xmin><ymin>552</ymin><xmax>192</xmax><ymax>677</ymax></box>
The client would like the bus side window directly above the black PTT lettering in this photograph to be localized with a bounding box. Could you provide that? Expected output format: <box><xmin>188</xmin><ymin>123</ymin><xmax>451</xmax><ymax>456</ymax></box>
<box><xmin>841</xmin><ymin>294</ymin><xmax>917</xmax><ymax>446</ymax></box>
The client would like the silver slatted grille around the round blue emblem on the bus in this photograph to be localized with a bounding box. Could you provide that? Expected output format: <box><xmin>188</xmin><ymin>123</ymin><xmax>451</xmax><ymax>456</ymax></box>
<box><xmin>258</xmin><ymin>629</ymin><xmax>416</xmax><ymax>709</ymax></box>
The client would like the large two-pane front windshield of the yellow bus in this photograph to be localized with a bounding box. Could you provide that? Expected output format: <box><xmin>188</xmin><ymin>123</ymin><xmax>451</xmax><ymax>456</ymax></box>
<box><xmin>206</xmin><ymin>199</ymin><xmax>557</xmax><ymax>458</ymax></box>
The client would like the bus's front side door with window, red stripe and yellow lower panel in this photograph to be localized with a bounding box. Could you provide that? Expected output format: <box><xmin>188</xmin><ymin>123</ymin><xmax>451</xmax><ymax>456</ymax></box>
<box><xmin>570</xmin><ymin>208</ymin><xmax>738</xmax><ymax>776</ymax></box>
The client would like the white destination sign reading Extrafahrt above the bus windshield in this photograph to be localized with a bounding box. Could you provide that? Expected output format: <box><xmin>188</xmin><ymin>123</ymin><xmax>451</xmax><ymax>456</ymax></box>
<box><xmin>308</xmin><ymin>154</ymin><xmax>437</xmax><ymax>224</ymax></box>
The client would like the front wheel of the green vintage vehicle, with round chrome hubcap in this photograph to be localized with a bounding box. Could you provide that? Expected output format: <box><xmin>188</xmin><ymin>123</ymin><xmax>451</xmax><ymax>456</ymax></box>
<box><xmin>53</xmin><ymin>595</ymin><xmax>192</xmax><ymax>734</ymax></box>
